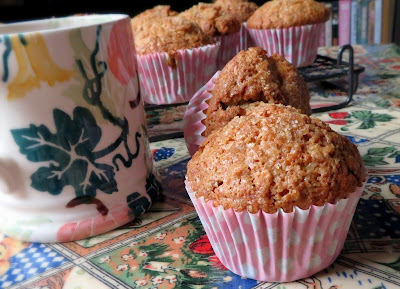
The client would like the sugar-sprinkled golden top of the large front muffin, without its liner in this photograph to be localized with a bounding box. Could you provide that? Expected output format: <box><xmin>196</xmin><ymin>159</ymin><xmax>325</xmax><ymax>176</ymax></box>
<box><xmin>187</xmin><ymin>102</ymin><xmax>366</xmax><ymax>213</ymax></box>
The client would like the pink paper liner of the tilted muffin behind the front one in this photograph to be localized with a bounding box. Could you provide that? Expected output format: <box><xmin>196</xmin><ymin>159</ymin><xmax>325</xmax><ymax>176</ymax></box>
<box><xmin>183</xmin><ymin>71</ymin><xmax>220</xmax><ymax>156</ymax></box>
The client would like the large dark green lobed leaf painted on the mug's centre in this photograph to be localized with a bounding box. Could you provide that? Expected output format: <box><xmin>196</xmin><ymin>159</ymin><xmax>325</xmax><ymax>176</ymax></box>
<box><xmin>12</xmin><ymin>107</ymin><xmax>118</xmax><ymax>197</ymax></box>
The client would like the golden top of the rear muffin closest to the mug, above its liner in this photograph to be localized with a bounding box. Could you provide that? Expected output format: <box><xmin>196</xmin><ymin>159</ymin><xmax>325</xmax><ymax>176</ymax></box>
<box><xmin>134</xmin><ymin>16</ymin><xmax>215</xmax><ymax>60</ymax></box>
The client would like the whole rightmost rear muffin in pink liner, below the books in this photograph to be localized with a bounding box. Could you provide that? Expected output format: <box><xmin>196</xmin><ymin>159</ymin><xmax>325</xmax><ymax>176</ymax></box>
<box><xmin>246</xmin><ymin>0</ymin><xmax>330</xmax><ymax>67</ymax></box>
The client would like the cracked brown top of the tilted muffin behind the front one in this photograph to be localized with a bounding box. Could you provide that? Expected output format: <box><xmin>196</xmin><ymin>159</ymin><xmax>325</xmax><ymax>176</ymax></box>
<box><xmin>203</xmin><ymin>47</ymin><xmax>311</xmax><ymax>136</ymax></box>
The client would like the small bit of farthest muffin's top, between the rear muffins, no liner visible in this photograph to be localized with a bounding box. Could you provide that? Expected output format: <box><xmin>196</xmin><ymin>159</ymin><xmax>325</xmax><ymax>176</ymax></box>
<box><xmin>215</xmin><ymin>0</ymin><xmax>258</xmax><ymax>23</ymax></box>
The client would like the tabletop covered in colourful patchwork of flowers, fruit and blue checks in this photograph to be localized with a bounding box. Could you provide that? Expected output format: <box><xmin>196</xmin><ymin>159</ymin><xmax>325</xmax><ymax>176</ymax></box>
<box><xmin>0</xmin><ymin>45</ymin><xmax>400</xmax><ymax>289</ymax></box>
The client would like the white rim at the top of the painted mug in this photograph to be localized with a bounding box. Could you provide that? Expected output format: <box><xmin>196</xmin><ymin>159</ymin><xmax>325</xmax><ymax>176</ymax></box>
<box><xmin>0</xmin><ymin>13</ymin><xmax>130</xmax><ymax>37</ymax></box>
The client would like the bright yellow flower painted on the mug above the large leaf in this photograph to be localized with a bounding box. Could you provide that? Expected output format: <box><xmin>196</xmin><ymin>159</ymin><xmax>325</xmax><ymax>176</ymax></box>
<box><xmin>7</xmin><ymin>33</ymin><xmax>73</xmax><ymax>100</ymax></box>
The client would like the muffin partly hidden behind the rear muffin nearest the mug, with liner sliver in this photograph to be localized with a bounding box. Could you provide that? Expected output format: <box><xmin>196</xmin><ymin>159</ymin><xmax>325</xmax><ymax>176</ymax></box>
<box><xmin>180</xmin><ymin>2</ymin><xmax>241</xmax><ymax>69</ymax></box>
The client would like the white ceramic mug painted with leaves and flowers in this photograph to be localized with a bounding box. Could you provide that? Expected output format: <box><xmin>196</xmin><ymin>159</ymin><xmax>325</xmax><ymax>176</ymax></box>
<box><xmin>0</xmin><ymin>14</ymin><xmax>160</xmax><ymax>242</ymax></box>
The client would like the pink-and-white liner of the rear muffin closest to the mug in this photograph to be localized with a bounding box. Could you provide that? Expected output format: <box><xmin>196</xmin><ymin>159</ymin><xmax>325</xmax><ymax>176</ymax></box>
<box><xmin>137</xmin><ymin>43</ymin><xmax>220</xmax><ymax>105</ymax></box>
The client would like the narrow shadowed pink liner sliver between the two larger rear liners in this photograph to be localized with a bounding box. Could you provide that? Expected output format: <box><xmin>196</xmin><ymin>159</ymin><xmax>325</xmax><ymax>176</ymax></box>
<box><xmin>215</xmin><ymin>30</ymin><xmax>242</xmax><ymax>70</ymax></box>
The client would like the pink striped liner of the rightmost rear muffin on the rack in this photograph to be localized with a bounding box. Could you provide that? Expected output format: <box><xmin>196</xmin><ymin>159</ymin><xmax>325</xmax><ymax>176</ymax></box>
<box><xmin>246</xmin><ymin>23</ymin><xmax>325</xmax><ymax>67</ymax></box>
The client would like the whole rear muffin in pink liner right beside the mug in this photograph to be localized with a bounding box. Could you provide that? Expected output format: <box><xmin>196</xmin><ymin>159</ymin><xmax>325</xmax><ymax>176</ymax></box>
<box><xmin>134</xmin><ymin>16</ymin><xmax>219</xmax><ymax>104</ymax></box>
